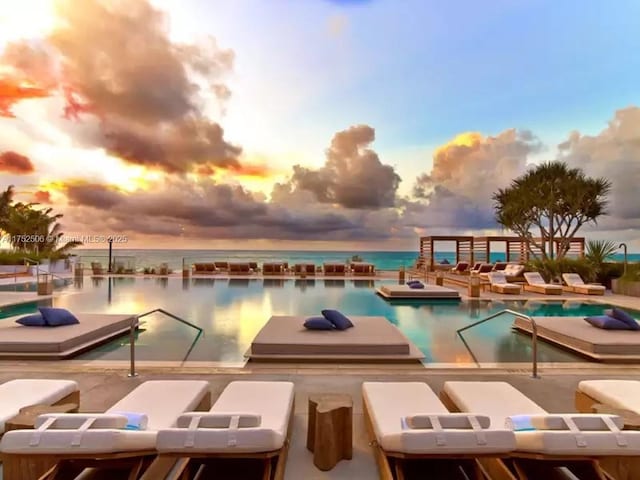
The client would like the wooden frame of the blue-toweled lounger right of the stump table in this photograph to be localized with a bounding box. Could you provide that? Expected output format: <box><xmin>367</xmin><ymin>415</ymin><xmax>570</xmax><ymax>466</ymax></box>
<box><xmin>439</xmin><ymin>390</ymin><xmax>616</xmax><ymax>480</ymax></box>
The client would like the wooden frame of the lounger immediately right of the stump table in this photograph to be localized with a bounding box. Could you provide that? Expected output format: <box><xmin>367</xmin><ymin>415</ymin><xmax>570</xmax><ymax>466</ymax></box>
<box><xmin>362</xmin><ymin>401</ymin><xmax>517</xmax><ymax>480</ymax></box>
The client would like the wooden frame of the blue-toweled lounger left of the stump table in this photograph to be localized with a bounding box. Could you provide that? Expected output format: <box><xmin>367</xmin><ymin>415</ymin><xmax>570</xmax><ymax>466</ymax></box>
<box><xmin>2</xmin><ymin>391</ymin><xmax>211</xmax><ymax>480</ymax></box>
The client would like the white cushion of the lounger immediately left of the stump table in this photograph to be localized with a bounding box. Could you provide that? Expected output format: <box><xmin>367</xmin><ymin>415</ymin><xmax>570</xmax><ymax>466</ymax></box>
<box><xmin>157</xmin><ymin>381</ymin><xmax>294</xmax><ymax>453</ymax></box>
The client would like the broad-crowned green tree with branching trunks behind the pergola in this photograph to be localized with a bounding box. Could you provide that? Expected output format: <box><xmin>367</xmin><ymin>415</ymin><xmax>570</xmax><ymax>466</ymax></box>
<box><xmin>493</xmin><ymin>161</ymin><xmax>611</xmax><ymax>260</ymax></box>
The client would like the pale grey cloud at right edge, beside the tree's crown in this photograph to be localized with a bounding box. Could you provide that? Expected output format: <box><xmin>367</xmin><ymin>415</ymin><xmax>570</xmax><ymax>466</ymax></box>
<box><xmin>558</xmin><ymin>107</ymin><xmax>640</xmax><ymax>228</ymax></box>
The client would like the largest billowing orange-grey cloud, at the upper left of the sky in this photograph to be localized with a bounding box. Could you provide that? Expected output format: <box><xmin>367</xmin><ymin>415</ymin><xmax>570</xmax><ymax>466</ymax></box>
<box><xmin>0</xmin><ymin>0</ymin><xmax>241</xmax><ymax>173</ymax></box>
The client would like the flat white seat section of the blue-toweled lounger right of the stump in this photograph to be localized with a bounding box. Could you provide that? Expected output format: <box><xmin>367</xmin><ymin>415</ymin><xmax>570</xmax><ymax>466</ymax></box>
<box><xmin>443</xmin><ymin>382</ymin><xmax>547</xmax><ymax>428</ymax></box>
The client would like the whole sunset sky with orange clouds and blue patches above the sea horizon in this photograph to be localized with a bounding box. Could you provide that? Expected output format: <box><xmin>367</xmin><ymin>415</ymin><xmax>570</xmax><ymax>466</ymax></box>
<box><xmin>0</xmin><ymin>0</ymin><xmax>640</xmax><ymax>251</ymax></box>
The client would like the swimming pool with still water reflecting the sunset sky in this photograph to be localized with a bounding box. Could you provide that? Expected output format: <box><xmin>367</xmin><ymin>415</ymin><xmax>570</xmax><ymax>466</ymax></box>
<box><xmin>0</xmin><ymin>277</ymin><xmax>620</xmax><ymax>363</ymax></box>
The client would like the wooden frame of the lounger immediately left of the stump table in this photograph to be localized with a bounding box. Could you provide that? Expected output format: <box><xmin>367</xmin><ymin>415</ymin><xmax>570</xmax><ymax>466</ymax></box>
<box><xmin>140</xmin><ymin>396</ymin><xmax>295</xmax><ymax>480</ymax></box>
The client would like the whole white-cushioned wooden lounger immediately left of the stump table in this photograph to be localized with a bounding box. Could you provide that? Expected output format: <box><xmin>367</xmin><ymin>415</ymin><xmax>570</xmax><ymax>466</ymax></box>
<box><xmin>143</xmin><ymin>381</ymin><xmax>294</xmax><ymax>480</ymax></box>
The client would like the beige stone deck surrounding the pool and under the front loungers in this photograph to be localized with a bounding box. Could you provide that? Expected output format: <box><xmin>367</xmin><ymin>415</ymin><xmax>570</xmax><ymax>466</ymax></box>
<box><xmin>0</xmin><ymin>272</ymin><xmax>640</xmax><ymax>480</ymax></box>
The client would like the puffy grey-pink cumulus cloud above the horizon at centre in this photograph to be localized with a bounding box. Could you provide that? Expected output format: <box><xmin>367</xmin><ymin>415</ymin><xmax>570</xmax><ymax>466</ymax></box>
<box><xmin>291</xmin><ymin>125</ymin><xmax>400</xmax><ymax>209</ymax></box>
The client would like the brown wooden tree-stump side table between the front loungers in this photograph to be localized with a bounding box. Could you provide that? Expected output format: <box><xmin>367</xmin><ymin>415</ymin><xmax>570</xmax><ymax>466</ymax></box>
<box><xmin>307</xmin><ymin>393</ymin><xmax>353</xmax><ymax>470</ymax></box>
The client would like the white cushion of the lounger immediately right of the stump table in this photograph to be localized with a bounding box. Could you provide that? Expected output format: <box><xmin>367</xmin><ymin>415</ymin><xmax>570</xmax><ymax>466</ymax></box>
<box><xmin>362</xmin><ymin>382</ymin><xmax>515</xmax><ymax>455</ymax></box>
